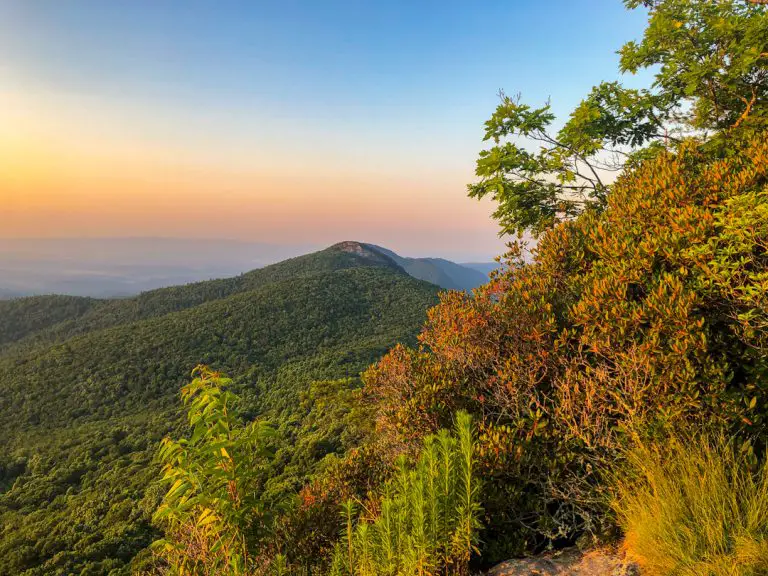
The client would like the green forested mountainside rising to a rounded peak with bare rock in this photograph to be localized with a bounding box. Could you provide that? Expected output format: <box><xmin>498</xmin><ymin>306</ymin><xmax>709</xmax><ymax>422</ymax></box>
<box><xmin>0</xmin><ymin>243</ymin><xmax>438</xmax><ymax>574</ymax></box>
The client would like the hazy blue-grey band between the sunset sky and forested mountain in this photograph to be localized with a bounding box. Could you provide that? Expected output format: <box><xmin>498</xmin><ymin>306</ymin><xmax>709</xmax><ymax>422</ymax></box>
<box><xmin>0</xmin><ymin>237</ymin><xmax>500</xmax><ymax>299</ymax></box>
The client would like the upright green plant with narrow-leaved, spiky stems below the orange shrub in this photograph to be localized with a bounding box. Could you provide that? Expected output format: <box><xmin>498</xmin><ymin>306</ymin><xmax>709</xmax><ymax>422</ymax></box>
<box><xmin>331</xmin><ymin>412</ymin><xmax>481</xmax><ymax>576</ymax></box>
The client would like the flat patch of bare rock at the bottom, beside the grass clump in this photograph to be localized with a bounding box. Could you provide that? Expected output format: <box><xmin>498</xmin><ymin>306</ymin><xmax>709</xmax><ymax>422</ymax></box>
<box><xmin>488</xmin><ymin>548</ymin><xmax>640</xmax><ymax>576</ymax></box>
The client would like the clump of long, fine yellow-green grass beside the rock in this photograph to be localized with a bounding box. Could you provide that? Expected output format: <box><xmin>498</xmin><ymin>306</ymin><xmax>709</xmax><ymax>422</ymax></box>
<box><xmin>614</xmin><ymin>436</ymin><xmax>768</xmax><ymax>576</ymax></box>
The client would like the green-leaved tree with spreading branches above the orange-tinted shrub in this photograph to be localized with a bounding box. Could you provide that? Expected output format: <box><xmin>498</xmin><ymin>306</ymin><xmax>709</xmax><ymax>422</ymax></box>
<box><xmin>469</xmin><ymin>0</ymin><xmax>768</xmax><ymax>234</ymax></box>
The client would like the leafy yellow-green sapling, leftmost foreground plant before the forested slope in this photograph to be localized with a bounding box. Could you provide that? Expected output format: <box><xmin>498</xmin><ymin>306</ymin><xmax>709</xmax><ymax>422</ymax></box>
<box><xmin>154</xmin><ymin>366</ymin><xmax>271</xmax><ymax>575</ymax></box>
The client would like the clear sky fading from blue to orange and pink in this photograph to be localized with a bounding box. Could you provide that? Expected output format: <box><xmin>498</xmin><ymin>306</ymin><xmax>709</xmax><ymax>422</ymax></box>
<box><xmin>0</xmin><ymin>0</ymin><xmax>645</xmax><ymax>260</ymax></box>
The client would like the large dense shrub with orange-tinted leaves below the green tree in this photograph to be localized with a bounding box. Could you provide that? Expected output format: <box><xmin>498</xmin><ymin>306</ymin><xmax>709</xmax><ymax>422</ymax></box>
<box><xmin>365</xmin><ymin>140</ymin><xmax>768</xmax><ymax>560</ymax></box>
